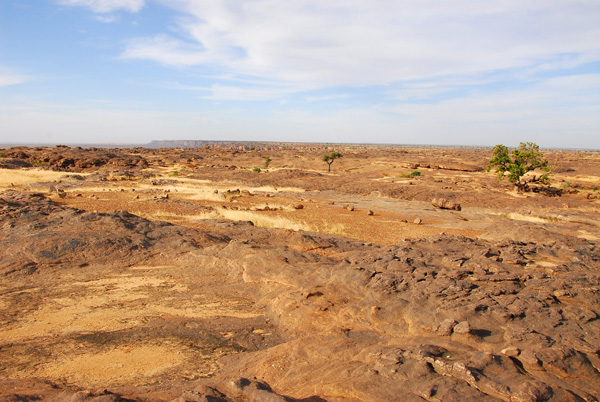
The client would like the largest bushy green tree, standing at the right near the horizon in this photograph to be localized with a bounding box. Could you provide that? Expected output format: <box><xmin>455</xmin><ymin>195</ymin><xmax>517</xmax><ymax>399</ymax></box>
<box><xmin>486</xmin><ymin>142</ymin><xmax>550</xmax><ymax>191</ymax></box>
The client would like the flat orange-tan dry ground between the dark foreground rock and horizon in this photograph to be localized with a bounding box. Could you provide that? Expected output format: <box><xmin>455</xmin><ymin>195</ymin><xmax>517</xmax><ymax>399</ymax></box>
<box><xmin>5</xmin><ymin>147</ymin><xmax>600</xmax><ymax>244</ymax></box>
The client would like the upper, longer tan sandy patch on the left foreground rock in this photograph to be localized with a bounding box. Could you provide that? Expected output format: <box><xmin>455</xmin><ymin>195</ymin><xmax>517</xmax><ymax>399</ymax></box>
<box><xmin>0</xmin><ymin>274</ymin><xmax>261</xmax><ymax>342</ymax></box>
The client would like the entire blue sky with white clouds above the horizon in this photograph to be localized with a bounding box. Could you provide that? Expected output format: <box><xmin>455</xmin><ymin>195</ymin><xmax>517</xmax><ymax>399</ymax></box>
<box><xmin>0</xmin><ymin>0</ymin><xmax>600</xmax><ymax>149</ymax></box>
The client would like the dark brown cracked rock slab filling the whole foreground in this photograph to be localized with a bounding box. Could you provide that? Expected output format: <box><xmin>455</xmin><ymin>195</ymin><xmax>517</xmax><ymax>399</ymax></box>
<box><xmin>0</xmin><ymin>191</ymin><xmax>600</xmax><ymax>401</ymax></box>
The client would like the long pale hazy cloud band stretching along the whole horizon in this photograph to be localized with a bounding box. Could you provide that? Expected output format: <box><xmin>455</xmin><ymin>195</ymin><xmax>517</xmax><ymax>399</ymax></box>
<box><xmin>0</xmin><ymin>74</ymin><xmax>600</xmax><ymax>149</ymax></box>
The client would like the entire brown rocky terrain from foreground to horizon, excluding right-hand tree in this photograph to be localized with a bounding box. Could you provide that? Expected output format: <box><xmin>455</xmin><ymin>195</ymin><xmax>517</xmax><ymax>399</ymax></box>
<box><xmin>0</xmin><ymin>145</ymin><xmax>600</xmax><ymax>402</ymax></box>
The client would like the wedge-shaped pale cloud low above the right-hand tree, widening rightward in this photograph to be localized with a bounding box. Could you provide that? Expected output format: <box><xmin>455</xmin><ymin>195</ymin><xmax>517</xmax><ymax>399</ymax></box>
<box><xmin>386</xmin><ymin>74</ymin><xmax>600</xmax><ymax>149</ymax></box>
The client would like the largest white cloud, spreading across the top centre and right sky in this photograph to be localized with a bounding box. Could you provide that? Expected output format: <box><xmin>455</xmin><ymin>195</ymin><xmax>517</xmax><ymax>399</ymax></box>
<box><xmin>123</xmin><ymin>0</ymin><xmax>600</xmax><ymax>95</ymax></box>
